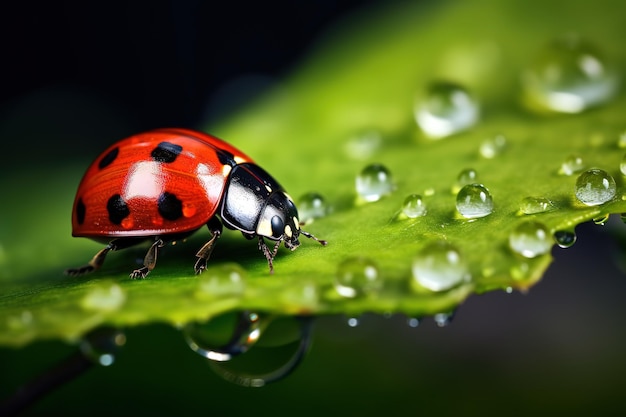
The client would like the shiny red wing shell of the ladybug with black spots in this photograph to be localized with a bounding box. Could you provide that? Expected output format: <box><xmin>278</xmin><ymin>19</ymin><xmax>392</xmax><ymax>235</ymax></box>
<box><xmin>72</xmin><ymin>128</ymin><xmax>253</xmax><ymax>239</ymax></box>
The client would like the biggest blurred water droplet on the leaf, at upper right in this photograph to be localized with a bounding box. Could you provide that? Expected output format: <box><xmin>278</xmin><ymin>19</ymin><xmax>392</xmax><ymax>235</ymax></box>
<box><xmin>522</xmin><ymin>35</ymin><xmax>618</xmax><ymax>113</ymax></box>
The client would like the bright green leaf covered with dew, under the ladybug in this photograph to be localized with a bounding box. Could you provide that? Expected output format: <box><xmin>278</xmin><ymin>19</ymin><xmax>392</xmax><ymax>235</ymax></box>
<box><xmin>0</xmin><ymin>0</ymin><xmax>626</xmax><ymax>346</ymax></box>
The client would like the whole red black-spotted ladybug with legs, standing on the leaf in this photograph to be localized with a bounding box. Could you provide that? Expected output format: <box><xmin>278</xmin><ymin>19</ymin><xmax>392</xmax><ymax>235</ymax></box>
<box><xmin>65</xmin><ymin>128</ymin><xmax>327</xmax><ymax>279</ymax></box>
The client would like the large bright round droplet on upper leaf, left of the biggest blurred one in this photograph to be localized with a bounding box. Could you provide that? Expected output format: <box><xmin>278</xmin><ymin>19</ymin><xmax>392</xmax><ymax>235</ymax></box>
<box><xmin>415</xmin><ymin>82</ymin><xmax>479</xmax><ymax>139</ymax></box>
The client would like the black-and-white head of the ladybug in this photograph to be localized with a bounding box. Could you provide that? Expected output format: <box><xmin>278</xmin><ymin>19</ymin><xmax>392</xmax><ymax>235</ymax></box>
<box><xmin>256</xmin><ymin>191</ymin><xmax>301</xmax><ymax>250</ymax></box>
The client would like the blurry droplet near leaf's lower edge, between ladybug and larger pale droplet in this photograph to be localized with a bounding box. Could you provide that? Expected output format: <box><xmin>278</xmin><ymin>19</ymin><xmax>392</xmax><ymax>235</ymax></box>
<box><xmin>335</xmin><ymin>257</ymin><xmax>383</xmax><ymax>298</ymax></box>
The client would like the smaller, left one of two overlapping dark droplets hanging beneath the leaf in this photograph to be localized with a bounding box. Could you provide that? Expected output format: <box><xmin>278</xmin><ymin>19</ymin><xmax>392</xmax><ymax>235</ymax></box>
<box><xmin>183</xmin><ymin>311</ymin><xmax>267</xmax><ymax>362</ymax></box>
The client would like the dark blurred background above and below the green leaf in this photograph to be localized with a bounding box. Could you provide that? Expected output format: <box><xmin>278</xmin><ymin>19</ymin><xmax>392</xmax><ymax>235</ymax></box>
<box><xmin>0</xmin><ymin>0</ymin><xmax>626</xmax><ymax>416</ymax></box>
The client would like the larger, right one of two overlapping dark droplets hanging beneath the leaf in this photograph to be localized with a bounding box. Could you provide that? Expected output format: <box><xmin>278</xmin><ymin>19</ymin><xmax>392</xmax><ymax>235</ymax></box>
<box><xmin>209</xmin><ymin>316</ymin><xmax>313</xmax><ymax>388</ymax></box>
